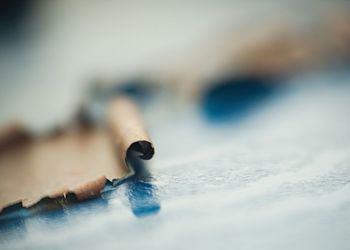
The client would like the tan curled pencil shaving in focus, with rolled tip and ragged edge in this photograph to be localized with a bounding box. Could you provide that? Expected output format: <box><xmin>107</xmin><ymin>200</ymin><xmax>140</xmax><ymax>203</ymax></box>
<box><xmin>0</xmin><ymin>98</ymin><xmax>154</xmax><ymax>211</ymax></box>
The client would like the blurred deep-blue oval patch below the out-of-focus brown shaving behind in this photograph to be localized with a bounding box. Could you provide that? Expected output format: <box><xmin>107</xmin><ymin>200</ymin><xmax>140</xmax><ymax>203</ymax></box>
<box><xmin>202</xmin><ymin>76</ymin><xmax>277</xmax><ymax>122</ymax></box>
